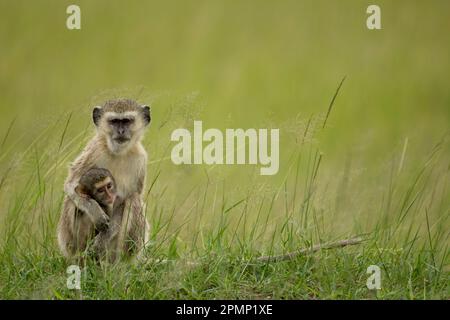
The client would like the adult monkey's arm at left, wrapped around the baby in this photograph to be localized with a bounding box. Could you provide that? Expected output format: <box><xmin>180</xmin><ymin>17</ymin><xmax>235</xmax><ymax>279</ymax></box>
<box><xmin>64</xmin><ymin>146</ymin><xmax>109</xmax><ymax>230</ymax></box>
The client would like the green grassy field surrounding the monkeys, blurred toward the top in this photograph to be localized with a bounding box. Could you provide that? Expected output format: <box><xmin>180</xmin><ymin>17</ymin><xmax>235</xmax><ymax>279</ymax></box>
<box><xmin>0</xmin><ymin>1</ymin><xmax>450</xmax><ymax>299</ymax></box>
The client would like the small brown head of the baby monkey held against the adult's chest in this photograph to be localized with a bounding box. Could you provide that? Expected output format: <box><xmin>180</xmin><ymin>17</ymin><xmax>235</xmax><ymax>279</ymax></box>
<box><xmin>78</xmin><ymin>168</ymin><xmax>116</xmax><ymax>208</ymax></box>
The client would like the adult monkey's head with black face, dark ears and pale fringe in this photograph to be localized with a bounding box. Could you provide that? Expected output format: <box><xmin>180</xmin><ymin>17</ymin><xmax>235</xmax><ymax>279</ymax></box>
<box><xmin>93</xmin><ymin>100</ymin><xmax>150</xmax><ymax>153</ymax></box>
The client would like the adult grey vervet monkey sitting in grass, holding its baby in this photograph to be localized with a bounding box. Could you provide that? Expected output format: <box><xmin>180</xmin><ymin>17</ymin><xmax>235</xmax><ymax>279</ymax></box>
<box><xmin>58</xmin><ymin>99</ymin><xmax>151</xmax><ymax>258</ymax></box>
